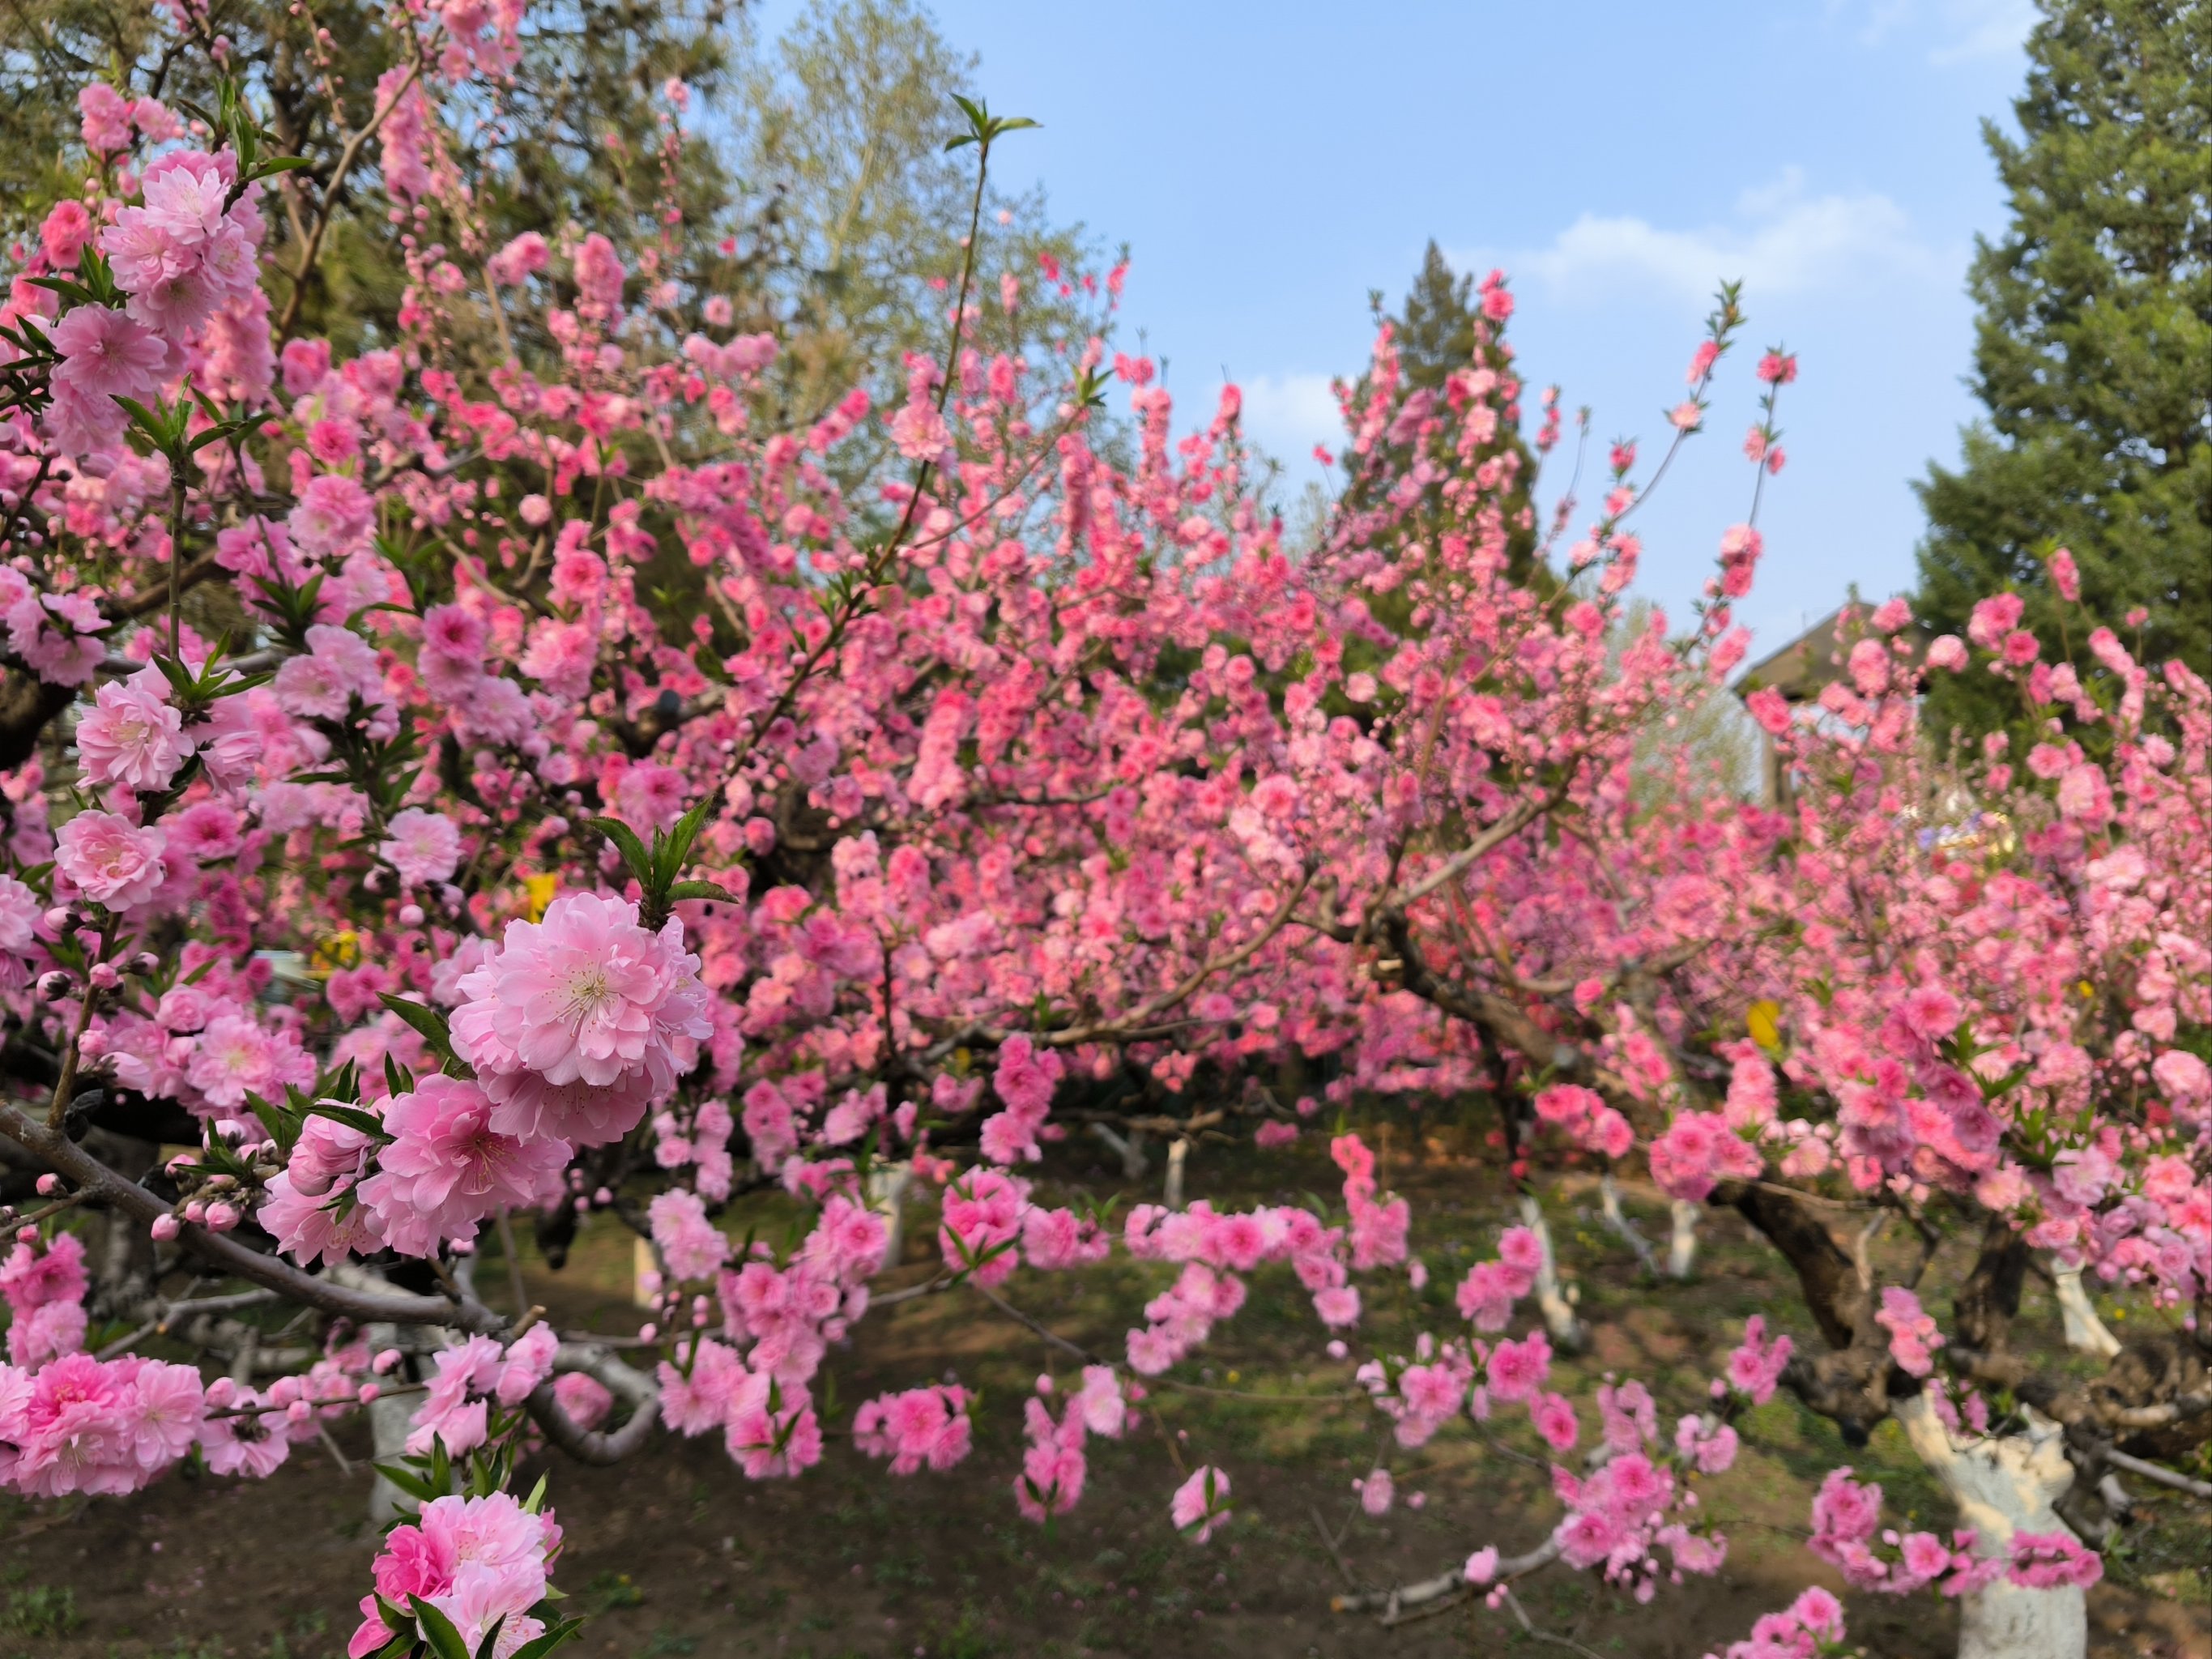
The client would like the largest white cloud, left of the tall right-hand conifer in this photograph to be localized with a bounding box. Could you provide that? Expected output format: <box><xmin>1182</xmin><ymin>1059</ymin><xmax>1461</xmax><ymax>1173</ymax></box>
<box><xmin>1495</xmin><ymin>168</ymin><xmax>1955</xmax><ymax>301</ymax></box>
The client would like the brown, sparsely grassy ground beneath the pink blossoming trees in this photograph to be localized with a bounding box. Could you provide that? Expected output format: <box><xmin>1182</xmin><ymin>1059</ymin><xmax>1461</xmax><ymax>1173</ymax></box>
<box><xmin>0</xmin><ymin>1124</ymin><xmax>2212</xmax><ymax>1659</ymax></box>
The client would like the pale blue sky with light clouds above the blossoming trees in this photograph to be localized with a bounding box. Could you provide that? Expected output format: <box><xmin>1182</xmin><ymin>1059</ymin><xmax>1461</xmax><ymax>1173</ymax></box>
<box><xmin>763</xmin><ymin>0</ymin><xmax>2033</xmax><ymax>644</ymax></box>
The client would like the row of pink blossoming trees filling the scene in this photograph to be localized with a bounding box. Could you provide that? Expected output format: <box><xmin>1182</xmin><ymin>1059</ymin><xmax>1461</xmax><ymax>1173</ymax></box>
<box><xmin>0</xmin><ymin>2</ymin><xmax>2212</xmax><ymax>1659</ymax></box>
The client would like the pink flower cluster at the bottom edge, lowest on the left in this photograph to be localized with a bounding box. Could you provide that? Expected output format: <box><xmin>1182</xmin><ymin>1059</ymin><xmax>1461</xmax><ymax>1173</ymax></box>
<box><xmin>345</xmin><ymin>1491</ymin><xmax>560</xmax><ymax>1659</ymax></box>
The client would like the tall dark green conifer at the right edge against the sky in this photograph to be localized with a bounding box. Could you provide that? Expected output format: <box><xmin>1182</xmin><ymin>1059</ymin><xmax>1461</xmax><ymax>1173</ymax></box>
<box><xmin>1918</xmin><ymin>0</ymin><xmax>2212</xmax><ymax>730</ymax></box>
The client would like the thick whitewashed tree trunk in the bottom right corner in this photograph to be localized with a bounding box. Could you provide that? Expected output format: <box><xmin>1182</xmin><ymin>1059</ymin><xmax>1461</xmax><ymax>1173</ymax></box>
<box><xmin>1895</xmin><ymin>1393</ymin><xmax>2088</xmax><ymax>1659</ymax></box>
